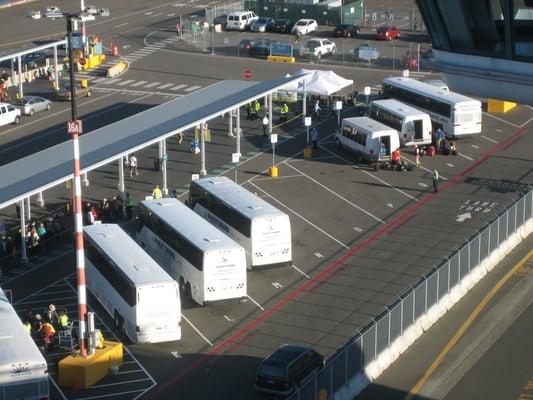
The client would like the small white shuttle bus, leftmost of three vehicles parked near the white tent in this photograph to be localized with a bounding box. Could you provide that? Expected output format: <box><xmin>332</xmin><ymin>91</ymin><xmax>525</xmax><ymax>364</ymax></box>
<box><xmin>335</xmin><ymin>117</ymin><xmax>400</xmax><ymax>162</ymax></box>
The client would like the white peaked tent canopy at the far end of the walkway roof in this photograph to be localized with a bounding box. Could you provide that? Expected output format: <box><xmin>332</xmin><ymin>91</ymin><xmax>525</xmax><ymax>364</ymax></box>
<box><xmin>281</xmin><ymin>68</ymin><xmax>353</xmax><ymax>96</ymax></box>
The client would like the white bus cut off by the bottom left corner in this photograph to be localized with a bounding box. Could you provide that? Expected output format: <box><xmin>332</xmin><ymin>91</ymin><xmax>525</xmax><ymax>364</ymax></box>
<box><xmin>0</xmin><ymin>289</ymin><xmax>49</xmax><ymax>400</ymax></box>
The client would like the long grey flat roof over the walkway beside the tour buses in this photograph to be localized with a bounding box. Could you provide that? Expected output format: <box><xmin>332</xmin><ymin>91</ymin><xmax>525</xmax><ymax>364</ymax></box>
<box><xmin>0</xmin><ymin>75</ymin><xmax>302</xmax><ymax>208</ymax></box>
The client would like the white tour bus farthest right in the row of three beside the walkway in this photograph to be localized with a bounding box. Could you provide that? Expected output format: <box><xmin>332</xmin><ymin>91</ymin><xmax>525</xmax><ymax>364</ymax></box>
<box><xmin>189</xmin><ymin>176</ymin><xmax>292</xmax><ymax>269</ymax></box>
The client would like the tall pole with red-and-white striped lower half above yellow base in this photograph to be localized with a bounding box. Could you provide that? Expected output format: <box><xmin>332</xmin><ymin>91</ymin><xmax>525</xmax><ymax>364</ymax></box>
<box><xmin>67</xmin><ymin>15</ymin><xmax>87</xmax><ymax>357</ymax></box>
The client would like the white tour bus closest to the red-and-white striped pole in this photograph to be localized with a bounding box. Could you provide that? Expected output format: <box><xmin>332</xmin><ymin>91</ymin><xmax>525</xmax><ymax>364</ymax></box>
<box><xmin>83</xmin><ymin>224</ymin><xmax>181</xmax><ymax>343</ymax></box>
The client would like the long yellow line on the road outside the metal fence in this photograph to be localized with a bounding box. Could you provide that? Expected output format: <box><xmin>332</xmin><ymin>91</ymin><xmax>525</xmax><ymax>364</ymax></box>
<box><xmin>404</xmin><ymin>250</ymin><xmax>533</xmax><ymax>400</ymax></box>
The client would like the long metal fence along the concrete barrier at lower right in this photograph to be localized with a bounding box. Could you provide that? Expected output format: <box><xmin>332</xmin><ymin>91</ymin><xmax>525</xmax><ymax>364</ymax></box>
<box><xmin>288</xmin><ymin>190</ymin><xmax>533</xmax><ymax>400</ymax></box>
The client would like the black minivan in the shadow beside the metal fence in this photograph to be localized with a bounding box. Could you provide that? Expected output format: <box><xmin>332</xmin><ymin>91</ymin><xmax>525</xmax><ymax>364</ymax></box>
<box><xmin>255</xmin><ymin>344</ymin><xmax>324</xmax><ymax>396</ymax></box>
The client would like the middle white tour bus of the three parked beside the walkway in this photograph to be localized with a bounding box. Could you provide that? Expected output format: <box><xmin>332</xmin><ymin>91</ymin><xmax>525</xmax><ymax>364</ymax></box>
<box><xmin>137</xmin><ymin>198</ymin><xmax>247</xmax><ymax>305</ymax></box>
